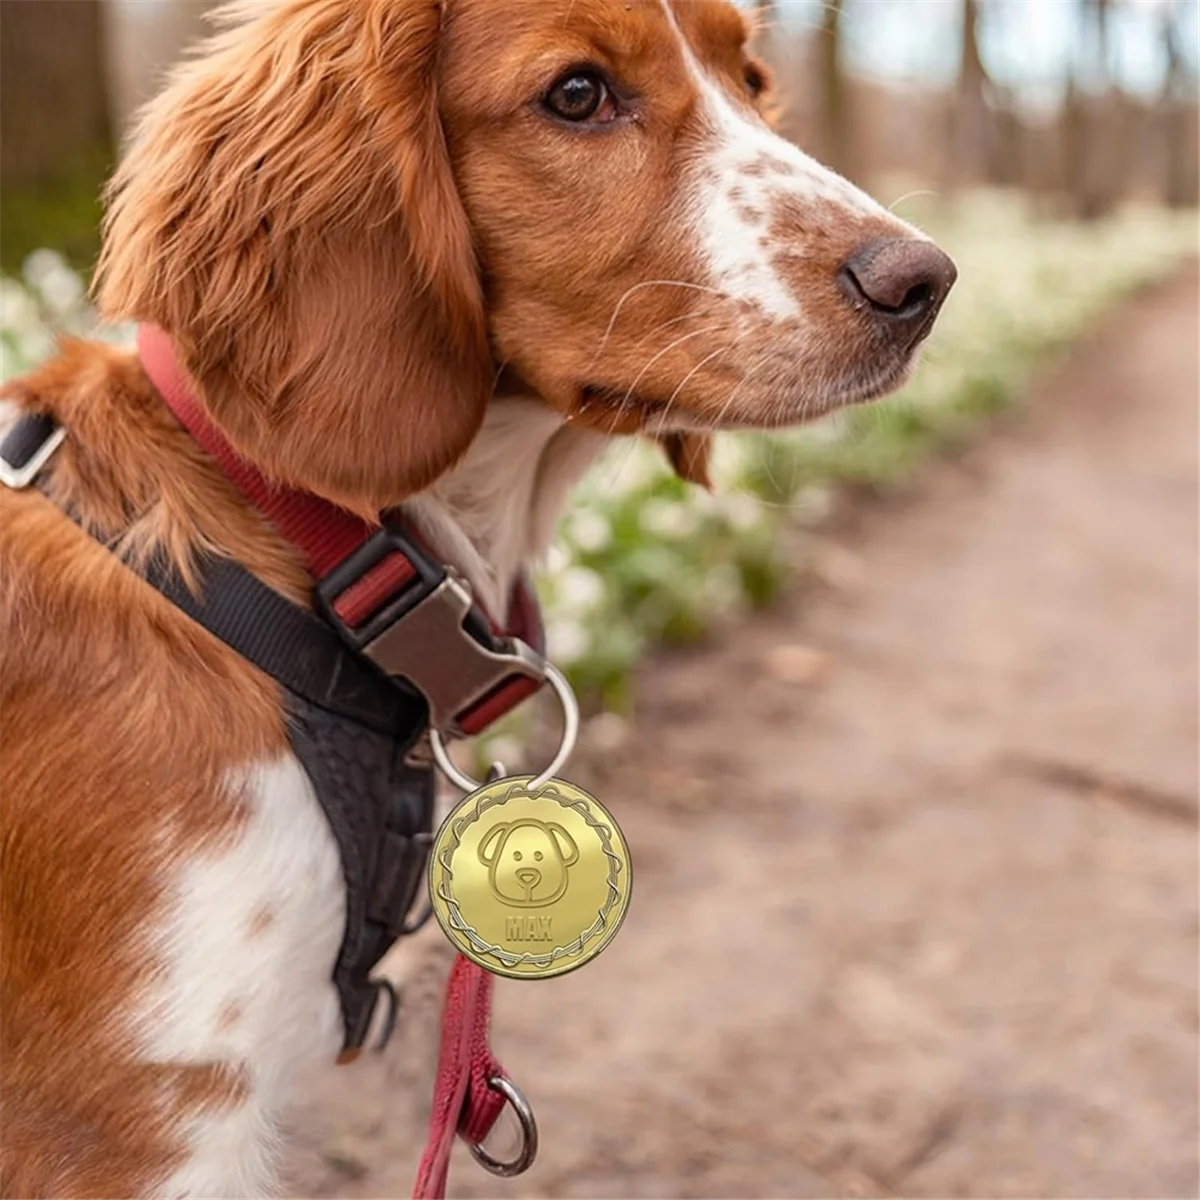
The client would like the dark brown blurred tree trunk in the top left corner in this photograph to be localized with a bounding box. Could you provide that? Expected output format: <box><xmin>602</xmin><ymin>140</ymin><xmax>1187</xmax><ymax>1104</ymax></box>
<box><xmin>0</xmin><ymin>0</ymin><xmax>112</xmax><ymax>190</ymax></box>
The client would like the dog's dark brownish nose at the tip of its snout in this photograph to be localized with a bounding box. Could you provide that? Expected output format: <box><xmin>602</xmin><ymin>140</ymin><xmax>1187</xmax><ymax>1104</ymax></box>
<box><xmin>839</xmin><ymin>238</ymin><xmax>959</xmax><ymax>344</ymax></box>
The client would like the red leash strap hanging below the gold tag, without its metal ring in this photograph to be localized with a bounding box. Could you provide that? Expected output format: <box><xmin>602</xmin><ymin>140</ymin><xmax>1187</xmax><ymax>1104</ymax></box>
<box><xmin>413</xmin><ymin>955</ymin><xmax>505</xmax><ymax>1200</ymax></box>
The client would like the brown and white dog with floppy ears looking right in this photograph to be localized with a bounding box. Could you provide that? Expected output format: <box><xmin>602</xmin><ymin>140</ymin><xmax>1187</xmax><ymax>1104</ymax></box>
<box><xmin>0</xmin><ymin>0</ymin><xmax>954</xmax><ymax>1200</ymax></box>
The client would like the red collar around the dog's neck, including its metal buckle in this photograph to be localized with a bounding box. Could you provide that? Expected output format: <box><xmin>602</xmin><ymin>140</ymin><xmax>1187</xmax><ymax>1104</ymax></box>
<box><xmin>138</xmin><ymin>325</ymin><xmax>545</xmax><ymax>734</ymax></box>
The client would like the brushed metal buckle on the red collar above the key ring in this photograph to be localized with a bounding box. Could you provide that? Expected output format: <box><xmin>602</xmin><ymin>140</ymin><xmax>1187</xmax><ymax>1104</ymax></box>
<box><xmin>362</xmin><ymin>575</ymin><xmax>546</xmax><ymax>737</ymax></box>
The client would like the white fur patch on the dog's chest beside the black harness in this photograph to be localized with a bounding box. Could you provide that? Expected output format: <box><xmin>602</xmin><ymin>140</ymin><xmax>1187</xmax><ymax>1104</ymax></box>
<box><xmin>143</xmin><ymin>755</ymin><xmax>346</xmax><ymax>1198</ymax></box>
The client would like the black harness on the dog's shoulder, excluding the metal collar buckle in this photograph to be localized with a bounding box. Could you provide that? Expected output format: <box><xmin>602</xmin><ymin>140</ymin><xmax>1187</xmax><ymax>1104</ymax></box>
<box><xmin>0</xmin><ymin>414</ymin><xmax>434</xmax><ymax>1061</ymax></box>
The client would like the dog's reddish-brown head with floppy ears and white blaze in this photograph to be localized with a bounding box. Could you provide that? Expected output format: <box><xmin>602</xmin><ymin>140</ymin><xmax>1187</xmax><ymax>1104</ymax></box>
<box><xmin>101</xmin><ymin>0</ymin><xmax>954</xmax><ymax>510</ymax></box>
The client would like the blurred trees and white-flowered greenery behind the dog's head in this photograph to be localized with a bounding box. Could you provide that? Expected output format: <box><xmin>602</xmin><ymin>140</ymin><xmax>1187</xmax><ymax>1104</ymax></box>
<box><xmin>0</xmin><ymin>0</ymin><xmax>1200</xmax><ymax>720</ymax></box>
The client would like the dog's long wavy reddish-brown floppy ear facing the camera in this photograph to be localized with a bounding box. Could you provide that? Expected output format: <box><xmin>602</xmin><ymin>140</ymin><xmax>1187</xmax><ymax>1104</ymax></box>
<box><xmin>98</xmin><ymin>0</ymin><xmax>493</xmax><ymax>512</ymax></box>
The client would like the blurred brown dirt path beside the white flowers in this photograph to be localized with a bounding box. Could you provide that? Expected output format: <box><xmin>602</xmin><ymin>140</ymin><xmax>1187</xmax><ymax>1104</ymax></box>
<box><xmin>290</xmin><ymin>269</ymin><xmax>1200</xmax><ymax>1200</ymax></box>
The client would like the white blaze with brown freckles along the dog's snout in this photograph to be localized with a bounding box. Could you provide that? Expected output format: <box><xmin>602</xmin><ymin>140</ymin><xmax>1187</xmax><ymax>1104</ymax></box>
<box><xmin>661</xmin><ymin>0</ymin><xmax>916</xmax><ymax>320</ymax></box>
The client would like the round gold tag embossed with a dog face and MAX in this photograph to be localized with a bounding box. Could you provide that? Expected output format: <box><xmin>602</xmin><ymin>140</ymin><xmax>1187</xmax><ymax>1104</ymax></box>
<box><xmin>430</xmin><ymin>775</ymin><xmax>631</xmax><ymax>979</ymax></box>
